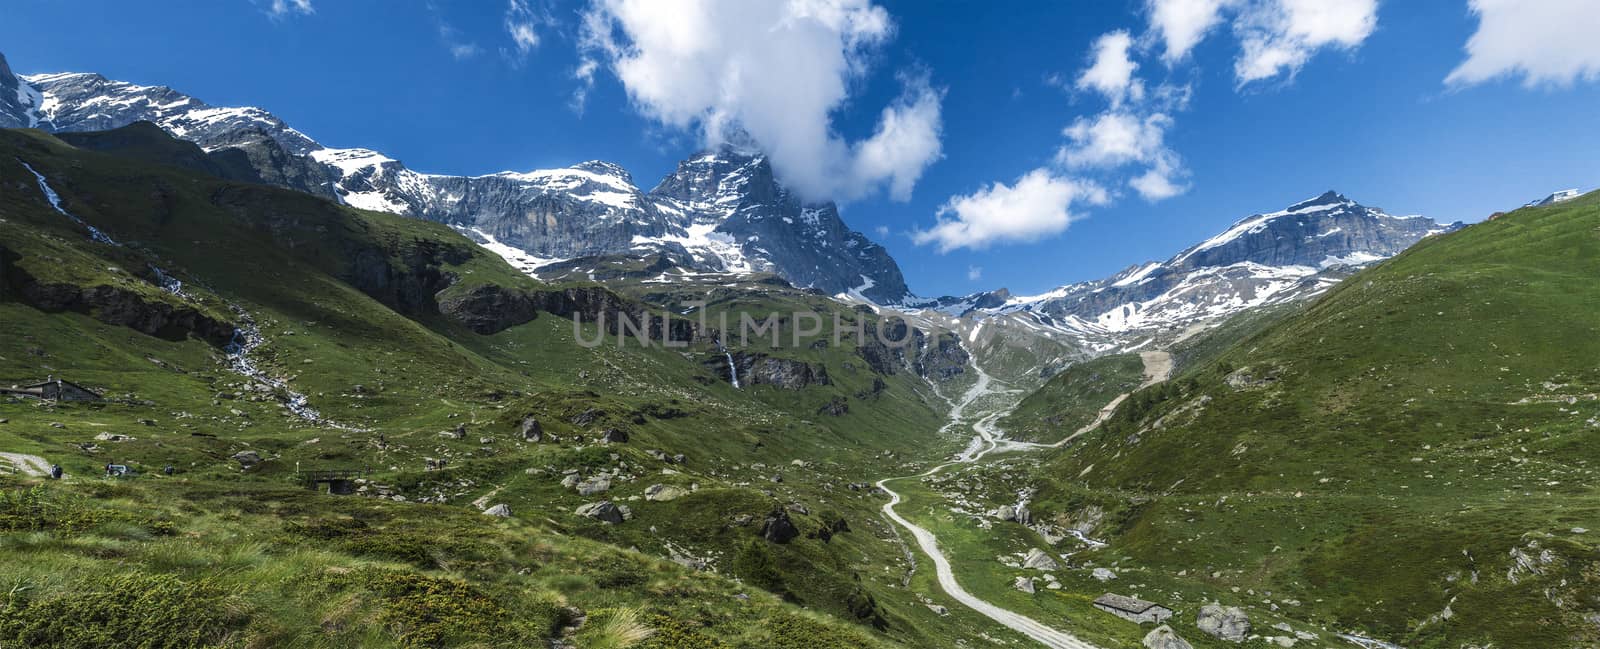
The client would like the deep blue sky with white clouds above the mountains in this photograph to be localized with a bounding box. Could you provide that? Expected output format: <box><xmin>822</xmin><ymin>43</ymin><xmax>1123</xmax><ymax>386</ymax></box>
<box><xmin>0</xmin><ymin>0</ymin><xmax>1600</xmax><ymax>294</ymax></box>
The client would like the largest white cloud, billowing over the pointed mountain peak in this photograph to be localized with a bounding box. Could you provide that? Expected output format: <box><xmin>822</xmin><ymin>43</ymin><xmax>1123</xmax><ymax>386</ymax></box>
<box><xmin>574</xmin><ymin>0</ymin><xmax>941</xmax><ymax>200</ymax></box>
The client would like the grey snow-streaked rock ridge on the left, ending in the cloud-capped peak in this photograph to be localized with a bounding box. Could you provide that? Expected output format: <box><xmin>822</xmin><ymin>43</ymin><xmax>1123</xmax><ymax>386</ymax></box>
<box><xmin>0</xmin><ymin>59</ymin><xmax>907</xmax><ymax>302</ymax></box>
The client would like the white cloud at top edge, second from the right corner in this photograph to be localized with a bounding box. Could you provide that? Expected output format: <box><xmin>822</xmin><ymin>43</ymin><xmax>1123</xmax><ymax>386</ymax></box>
<box><xmin>1234</xmin><ymin>0</ymin><xmax>1378</xmax><ymax>85</ymax></box>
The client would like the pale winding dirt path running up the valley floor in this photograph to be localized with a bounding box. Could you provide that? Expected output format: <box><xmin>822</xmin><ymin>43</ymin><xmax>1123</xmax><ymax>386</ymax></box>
<box><xmin>877</xmin><ymin>352</ymin><xmax>1173</xmax><ymax>649</ymax></box>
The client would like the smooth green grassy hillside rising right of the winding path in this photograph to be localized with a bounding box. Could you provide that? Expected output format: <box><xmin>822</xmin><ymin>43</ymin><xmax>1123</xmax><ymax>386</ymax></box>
<box><xmin>1034</xmin><ymin>195</ymin><xmax>1600</xmax><ymax>647</ymax></box>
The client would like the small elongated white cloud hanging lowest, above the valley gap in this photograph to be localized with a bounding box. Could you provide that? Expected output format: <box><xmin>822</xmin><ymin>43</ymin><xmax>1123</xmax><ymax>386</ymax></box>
<box><xmin>912</xmin><ymin>169</ymin><xmax>1107</xmax><ymax>253</ymax></box>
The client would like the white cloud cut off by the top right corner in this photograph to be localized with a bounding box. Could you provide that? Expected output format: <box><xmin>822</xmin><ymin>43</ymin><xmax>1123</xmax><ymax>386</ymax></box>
<box><xmin>1445</xmin><ymin>0</ymin><xmax>1600</xmax><ymax>88</ymax></box>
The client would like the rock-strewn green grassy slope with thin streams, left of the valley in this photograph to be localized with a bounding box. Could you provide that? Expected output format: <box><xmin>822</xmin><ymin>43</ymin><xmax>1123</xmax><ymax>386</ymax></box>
<box><xmin>0</xmin><ymin>125</ymin><xmax>1024</xmax><ymax>646</ymax></box>
